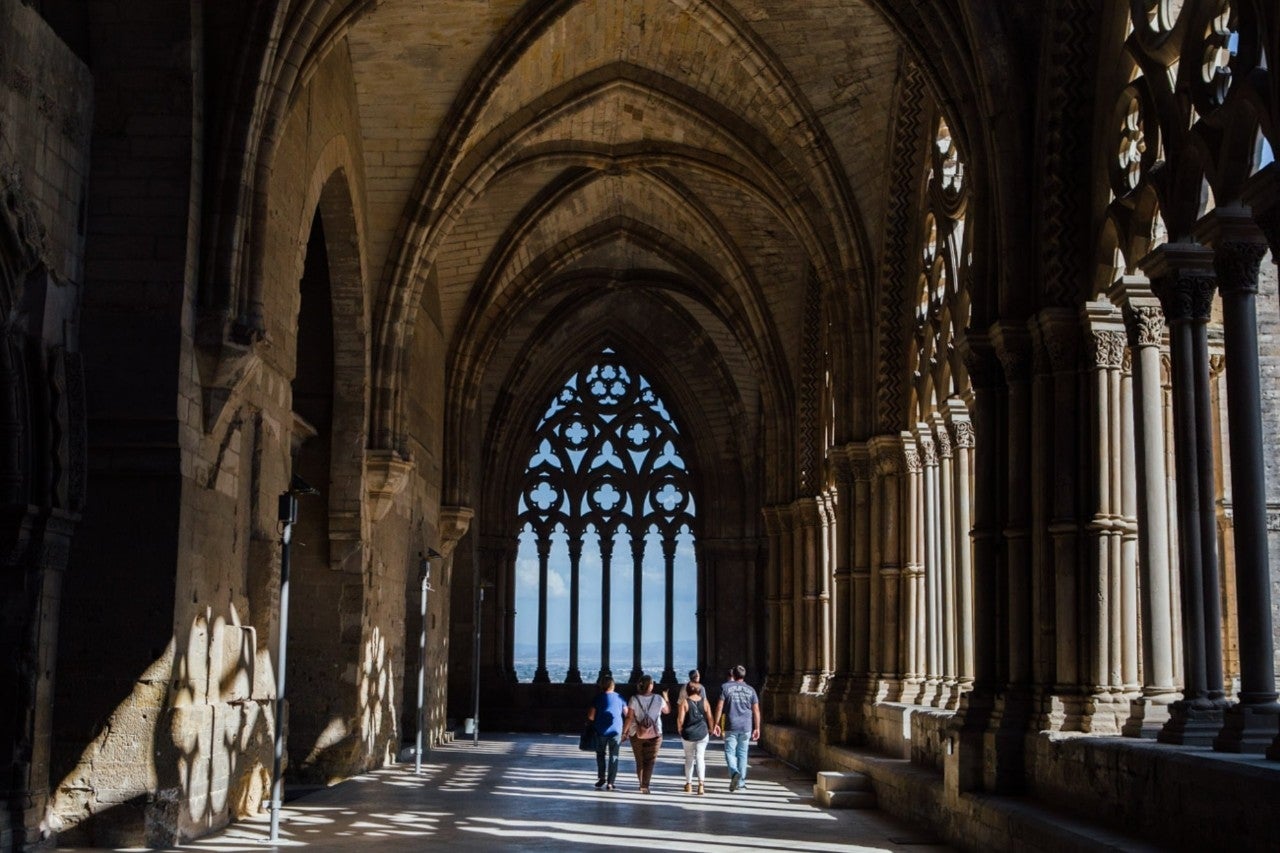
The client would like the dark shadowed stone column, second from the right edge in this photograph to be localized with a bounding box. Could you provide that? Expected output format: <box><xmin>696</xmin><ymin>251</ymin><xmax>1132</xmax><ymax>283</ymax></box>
<box><xmin>1140</xmin><ymin>243</ymin><xmax>1224</xmax><ymax>745</ymax></box>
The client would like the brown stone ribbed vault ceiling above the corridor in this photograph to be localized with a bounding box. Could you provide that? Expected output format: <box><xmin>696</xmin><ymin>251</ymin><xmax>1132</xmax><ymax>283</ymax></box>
<box><xmin>347</xmin><ymin>0</ymin><xmax>921</xmax><ymax>502</ymax></box>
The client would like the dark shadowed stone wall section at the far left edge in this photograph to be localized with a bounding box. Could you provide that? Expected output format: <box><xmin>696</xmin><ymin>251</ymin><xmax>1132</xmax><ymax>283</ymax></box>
<box><xmin>0</xmin><ymin>3</ymin><xmax>93</xmax><ymax>849</ymax></box>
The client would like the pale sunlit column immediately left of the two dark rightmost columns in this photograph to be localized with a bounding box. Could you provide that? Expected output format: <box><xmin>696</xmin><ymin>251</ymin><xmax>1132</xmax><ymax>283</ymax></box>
<box><xmin>1111</xmin><ymin>275</ymin><xmax>1178</xmax><ymax>738</ymax></box>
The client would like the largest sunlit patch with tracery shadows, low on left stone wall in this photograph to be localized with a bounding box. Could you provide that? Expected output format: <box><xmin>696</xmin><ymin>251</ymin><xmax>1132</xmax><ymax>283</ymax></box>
<box><xmin>45</xmin><ymin>606</ymin><xmax>274</xmax><ymax>847</ymax></box>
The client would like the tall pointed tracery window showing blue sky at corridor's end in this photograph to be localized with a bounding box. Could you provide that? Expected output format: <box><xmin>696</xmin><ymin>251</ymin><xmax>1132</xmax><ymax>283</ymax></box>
<box><xmin>516</xmin><ymin>348</ymin><xmax>698</xmax><ymax>683</ymax></box>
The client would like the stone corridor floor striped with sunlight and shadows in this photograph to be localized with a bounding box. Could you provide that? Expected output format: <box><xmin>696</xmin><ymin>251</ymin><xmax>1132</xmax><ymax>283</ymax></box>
<box><xmin>63</xmin><ymin>735</ymin><xmax>951</xmax><ymax>853</ymax></box>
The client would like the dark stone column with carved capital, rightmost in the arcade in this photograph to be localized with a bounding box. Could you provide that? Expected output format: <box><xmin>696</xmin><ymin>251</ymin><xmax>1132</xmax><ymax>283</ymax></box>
<box><xmin>1197</xmin><ymin>199</ymin><xmax>1280</xmax><ymax>753</ymax></box>
